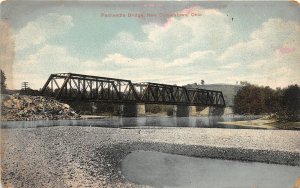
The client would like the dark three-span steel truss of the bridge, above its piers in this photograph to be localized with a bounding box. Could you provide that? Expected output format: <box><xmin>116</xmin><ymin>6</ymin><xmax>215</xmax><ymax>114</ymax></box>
<box><xmin>41</xmin><ymin>73</ymin><xmax>225</xmax><ymax>107</ymax></box>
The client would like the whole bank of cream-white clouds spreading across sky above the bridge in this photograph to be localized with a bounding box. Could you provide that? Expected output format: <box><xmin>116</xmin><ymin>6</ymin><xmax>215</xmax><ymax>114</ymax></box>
<box><xmin>14</xmin><ymin>7</ymin><xmax>300</xmax><ymax>88</ymax></box>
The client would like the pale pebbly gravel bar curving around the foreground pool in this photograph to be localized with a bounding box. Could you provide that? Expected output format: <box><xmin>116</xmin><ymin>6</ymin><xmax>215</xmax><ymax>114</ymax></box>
<box><xmin>1</xmin><ymin>126</ymin><xmax>300</xmax><ymax>187</ymax></box>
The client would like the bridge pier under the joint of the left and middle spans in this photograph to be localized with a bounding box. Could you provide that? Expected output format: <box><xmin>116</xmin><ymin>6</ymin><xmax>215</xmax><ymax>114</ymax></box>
<box><xmin>120</xmin><ymin>104</ymin><xmax>146</xmax><ymax>117</ymax></box>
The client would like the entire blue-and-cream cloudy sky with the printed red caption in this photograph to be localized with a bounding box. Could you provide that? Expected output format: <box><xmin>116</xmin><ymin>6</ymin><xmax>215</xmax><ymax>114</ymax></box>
<box><xmin>0</xmin><ymin>1</ymin><xmax>300</xmax><ymax>89</ymax></box>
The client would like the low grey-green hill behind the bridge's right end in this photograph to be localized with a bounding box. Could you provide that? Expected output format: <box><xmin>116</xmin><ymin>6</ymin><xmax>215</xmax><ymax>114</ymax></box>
<box><xmin>185</xmin><ymin>83</ymin><xmax>242</xmax><ymax>106</ymax></box>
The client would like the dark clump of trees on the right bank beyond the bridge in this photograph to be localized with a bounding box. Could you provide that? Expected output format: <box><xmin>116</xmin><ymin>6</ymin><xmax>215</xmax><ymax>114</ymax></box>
<box><xmin>233</xmin><ymin>82</ymin><xmax>300</xmax><ymax>121</ymax></box>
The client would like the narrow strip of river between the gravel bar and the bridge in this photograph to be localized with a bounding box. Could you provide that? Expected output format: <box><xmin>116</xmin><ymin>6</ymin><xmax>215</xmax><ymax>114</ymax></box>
<box><xmin>1</xmin><ymin>115</ymin><xmax>259</xmax><ymax>128</ymax></box>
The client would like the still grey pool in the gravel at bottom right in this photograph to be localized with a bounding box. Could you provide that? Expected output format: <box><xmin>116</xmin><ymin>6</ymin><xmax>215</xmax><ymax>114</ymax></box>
<box><xmin>122</xmin><ymin>151</ymin><xmax>300</xmax><ymax>188</ymax></box>
